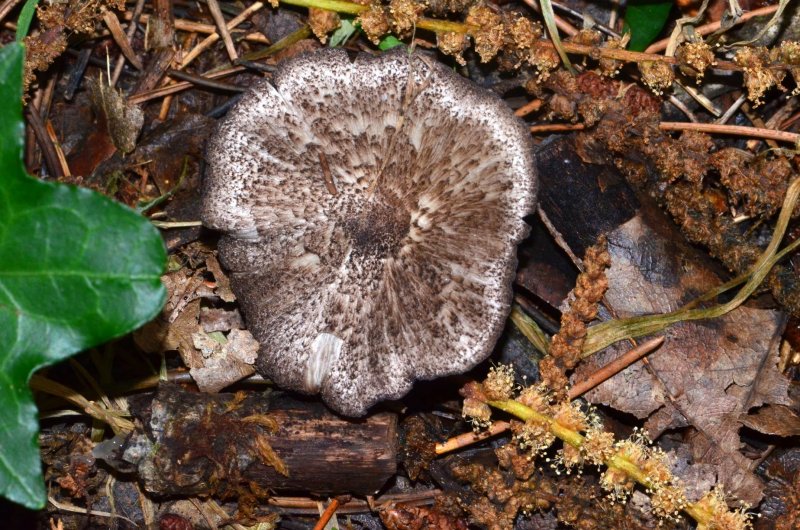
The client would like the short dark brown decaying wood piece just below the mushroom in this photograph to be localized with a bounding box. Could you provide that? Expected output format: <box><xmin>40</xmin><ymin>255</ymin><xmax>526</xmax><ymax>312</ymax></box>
<box><xmin>123</xmin><ymin>384</ymin><xmax>398</xmax><ymax>496</ymax></box>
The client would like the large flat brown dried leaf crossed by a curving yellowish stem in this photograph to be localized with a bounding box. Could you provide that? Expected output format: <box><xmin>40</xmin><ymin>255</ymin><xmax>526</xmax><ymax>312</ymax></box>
<box><xmin>576</xmin><ymin>216</ymin><xmax>788</xmax><ymax>503</ymax></box>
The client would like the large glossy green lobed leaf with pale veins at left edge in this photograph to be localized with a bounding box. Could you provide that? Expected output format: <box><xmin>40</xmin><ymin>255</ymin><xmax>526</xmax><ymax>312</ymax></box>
<box><xmin>0</xmin><ymin>43</ymin><xmax>166</xmax><ymax>508</ymax></box>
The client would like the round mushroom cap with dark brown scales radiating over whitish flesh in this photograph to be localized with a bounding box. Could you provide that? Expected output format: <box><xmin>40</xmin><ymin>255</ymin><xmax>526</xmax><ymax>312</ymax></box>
<box><xmin>202</xmin><ymin>50</ymin><xmax>537</xmax><ymax>416</ymax></box>
